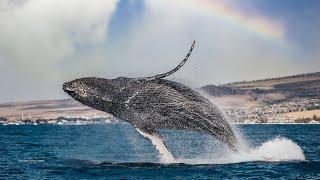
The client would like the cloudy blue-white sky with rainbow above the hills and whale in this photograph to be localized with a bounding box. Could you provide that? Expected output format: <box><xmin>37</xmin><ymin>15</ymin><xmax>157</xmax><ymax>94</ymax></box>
<box><xmin>0</xmin><ymin>0</ymin><xmax>320</xmax><ymax>103</ymax></box>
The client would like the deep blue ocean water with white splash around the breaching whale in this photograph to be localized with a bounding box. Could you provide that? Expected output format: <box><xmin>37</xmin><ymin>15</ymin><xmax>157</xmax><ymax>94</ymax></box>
<box><xmin>0</xmin><ymin>123</ymin><xmax>320</xmax><ymax>179</ymax></box>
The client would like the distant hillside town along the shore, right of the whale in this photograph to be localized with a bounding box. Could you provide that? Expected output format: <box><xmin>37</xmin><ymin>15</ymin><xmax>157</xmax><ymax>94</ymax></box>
<box><xmin>222</xmin><ymin>98</ymin><xmax>320</xmax><ymax>124</ymax></box>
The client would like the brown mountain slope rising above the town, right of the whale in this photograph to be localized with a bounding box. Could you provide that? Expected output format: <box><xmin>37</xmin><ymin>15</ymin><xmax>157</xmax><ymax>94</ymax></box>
<box><xmin>201</xmin><ymin>72</ymin><xmax>320</xmax><ymax>102</ymax></box>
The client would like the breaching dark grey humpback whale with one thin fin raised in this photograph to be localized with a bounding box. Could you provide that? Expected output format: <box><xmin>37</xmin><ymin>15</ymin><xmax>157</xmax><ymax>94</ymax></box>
<box><xmin>63</xmin><ymin>42</ymin><xmax>237</xmax><ymax>162</ymax></box>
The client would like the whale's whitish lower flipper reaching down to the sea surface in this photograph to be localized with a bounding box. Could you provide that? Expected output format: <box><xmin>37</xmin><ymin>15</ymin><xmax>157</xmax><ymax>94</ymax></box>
<box><xmin>137</xmin><ymin>129</ymin><xmax>177</xmax><ymax>164</ymax></box>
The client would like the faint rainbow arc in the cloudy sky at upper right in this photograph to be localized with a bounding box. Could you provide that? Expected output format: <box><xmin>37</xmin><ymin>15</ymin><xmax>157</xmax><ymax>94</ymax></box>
<box><xmin>172</xmin><ymin>0</ymin><xmax>285</xmax><ymax>40</ymax></box>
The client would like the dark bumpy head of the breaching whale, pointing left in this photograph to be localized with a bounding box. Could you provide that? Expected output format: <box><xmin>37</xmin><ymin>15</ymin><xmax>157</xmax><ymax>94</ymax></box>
<box><xmin>63</xmin><ymin>77</ymin><xmax>124</xmax><ymax>115</ymax></box>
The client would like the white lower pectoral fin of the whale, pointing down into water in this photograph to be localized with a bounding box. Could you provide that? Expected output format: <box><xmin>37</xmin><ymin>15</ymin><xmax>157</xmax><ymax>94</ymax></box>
<box><xmin>137</xmin><ymin>128</ymin><xmax>176</xmax><ymax>163</ymax></box>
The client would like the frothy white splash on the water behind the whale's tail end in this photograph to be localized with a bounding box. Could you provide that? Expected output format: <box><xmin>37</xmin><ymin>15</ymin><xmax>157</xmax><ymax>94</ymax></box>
<box><xmin>178</xmin><ymin>137</ymin><xmax>305</xmax><ymax>164</ymax></box>
